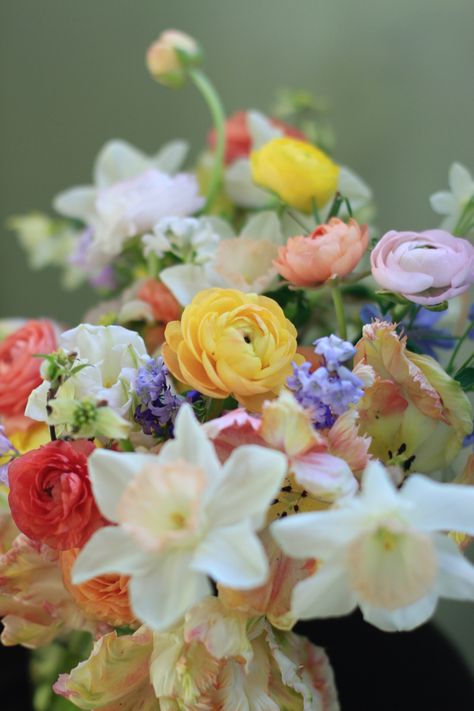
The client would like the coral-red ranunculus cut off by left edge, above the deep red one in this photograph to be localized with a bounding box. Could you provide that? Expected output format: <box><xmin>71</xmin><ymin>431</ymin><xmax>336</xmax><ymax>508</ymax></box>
<box><xmin>0</xmin><ymin>320</ymin><xmax>57</xmax><ymax>433</ymax></box>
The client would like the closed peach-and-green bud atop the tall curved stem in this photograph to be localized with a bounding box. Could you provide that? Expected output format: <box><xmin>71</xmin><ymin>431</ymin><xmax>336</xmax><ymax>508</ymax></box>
<box><xmin>146</xmin><ymin>30</ymin><xmax>202</xmax><ymax>89</ymax></box>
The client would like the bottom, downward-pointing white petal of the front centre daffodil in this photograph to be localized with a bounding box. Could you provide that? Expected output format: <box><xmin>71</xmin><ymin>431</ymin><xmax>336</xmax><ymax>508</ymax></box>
<box><xmin>129</xmin><ymin>551</ymin><xmax>212</xmax><ymax>631</ymax></box>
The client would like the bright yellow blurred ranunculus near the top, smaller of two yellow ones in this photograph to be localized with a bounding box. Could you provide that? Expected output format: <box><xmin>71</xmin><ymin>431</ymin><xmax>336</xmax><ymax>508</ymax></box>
<box><xmin>250</xmin><ymin>138</ymin><xmax>339</xmax><ymax>212</ymax></box>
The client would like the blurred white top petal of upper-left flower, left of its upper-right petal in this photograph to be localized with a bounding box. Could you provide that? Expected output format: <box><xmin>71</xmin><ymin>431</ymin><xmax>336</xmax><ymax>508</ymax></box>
<box><xmin>94</xmin><ymin>140</ymin><xmax>152</xmax><ymax>188</ymax></box>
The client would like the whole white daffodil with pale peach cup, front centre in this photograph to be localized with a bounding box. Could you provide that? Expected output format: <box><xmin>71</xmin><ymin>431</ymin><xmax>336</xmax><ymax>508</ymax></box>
<box><xmin>73</xmin><ymin>405</ymin><xmax>287</xmax><ymax>630</ymax></box>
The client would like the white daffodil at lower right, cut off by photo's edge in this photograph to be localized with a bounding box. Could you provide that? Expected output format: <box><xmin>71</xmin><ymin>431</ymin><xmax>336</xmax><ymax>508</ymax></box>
<box><xmin>271</xmin><ymin>462</ymin><xmax>474</xmax><ymax>631</ymax></box>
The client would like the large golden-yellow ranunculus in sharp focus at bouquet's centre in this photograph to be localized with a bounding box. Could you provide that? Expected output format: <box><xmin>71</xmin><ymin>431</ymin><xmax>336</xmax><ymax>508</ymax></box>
<box><xmin>163</xmin><ymin>289</ymin><xmax>304</xmax><ymax>410</ymax></box>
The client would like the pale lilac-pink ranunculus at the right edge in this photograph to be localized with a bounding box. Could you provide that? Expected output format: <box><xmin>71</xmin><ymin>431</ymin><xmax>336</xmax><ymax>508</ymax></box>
<box><xmin>370</xmin><ymin>230</ymin><xmax>474</xmax><ymax>306</ymax></box>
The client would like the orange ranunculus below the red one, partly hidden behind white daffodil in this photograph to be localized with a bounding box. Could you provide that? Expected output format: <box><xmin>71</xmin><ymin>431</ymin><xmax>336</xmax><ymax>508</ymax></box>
<box><xmin>60</xmin><ymin>548</ymin><xmax>135</xmax><ymax>627</ymax></box>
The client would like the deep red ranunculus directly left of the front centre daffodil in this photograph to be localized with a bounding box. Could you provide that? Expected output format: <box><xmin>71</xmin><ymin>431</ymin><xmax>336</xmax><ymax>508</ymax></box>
<box><xmin>8</xmin><ymin>440</ymin><xmax>106</xmax><ymax>550</ymax></box>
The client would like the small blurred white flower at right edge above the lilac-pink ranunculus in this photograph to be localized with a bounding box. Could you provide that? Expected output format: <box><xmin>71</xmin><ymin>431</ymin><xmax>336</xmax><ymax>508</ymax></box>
<box><xmin>430</xmin><ymin>163</ymin><xmax>474</xmax><ymax>237</ymax></box>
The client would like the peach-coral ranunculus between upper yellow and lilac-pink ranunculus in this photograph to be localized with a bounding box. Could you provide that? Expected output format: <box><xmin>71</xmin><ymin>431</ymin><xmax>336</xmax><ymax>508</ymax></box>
<box><xmin>274</xmin><ymin>217</ymin><xmax>369</xmax><ymax>286</ymax></box>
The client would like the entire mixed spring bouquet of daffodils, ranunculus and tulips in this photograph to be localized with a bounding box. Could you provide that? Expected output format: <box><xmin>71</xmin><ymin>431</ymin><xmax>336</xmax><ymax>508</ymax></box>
<box><xmin>0</xmin><ymin>31</ymin><xmax>474</xmax><ymax>711</ymax></box>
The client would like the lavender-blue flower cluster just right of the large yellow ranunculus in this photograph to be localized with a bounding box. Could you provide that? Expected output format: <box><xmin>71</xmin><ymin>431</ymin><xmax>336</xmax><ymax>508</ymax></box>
<box><xmin>287</xmin><ymin>335</ymin><xmax>364</xmax><ymax>429</ymax></box>
